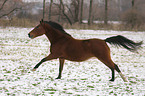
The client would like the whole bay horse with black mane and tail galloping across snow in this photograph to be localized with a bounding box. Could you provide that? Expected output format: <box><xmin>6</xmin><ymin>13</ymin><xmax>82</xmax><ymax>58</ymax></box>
<box><xmin>28</xmin><ymin>20</ymin><xmax>142</xmax><ymax>82</ymax></box>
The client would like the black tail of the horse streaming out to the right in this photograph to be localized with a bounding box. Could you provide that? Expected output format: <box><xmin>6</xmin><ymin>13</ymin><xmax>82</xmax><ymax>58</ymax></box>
<box><xmin>105</xmin><ymin>35</ymin><xmax>143</xmax><ymax>52</ymax></box>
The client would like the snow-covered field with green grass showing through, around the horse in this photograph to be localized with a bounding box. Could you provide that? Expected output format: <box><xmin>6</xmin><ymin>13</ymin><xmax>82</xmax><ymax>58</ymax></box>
<box><xmin>0</xmin><ymin>28</ymin><xmax>145</xmax><ymax>96</ymax></box>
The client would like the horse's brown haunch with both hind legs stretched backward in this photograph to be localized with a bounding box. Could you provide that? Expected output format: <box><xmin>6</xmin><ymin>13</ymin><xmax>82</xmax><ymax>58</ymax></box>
<box><xmin>92</xmin><ymin>43</ymin><xmax>127</xmax><ymax>82</ymax></box>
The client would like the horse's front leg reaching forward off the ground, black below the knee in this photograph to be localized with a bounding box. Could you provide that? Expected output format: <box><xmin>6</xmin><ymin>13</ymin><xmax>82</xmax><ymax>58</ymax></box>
<box><xmin>32</xmin><ymin>54</ymin><xmax>57</xmax><ymax>71</ymax></box>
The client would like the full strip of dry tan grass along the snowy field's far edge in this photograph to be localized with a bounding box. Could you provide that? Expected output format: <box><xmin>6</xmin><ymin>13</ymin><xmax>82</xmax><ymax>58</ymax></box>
<box><xmin>0</xmin><ymin>18</ymin><xmax>145</xmax><ymax>31</ymax></box>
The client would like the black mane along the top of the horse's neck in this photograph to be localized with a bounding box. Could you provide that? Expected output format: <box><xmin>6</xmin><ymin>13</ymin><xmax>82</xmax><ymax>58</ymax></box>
<box><xmin>44</xmin><ymin>21</ymin><xmax>71</xmax><ymax>36</ymax></box>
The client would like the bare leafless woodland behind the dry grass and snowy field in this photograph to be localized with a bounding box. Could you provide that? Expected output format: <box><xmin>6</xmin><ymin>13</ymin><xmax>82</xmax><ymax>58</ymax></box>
<box><xmin>0</xmin><ymin>0</ymin><xmax>145</xmax><ymax>28</ymax></box>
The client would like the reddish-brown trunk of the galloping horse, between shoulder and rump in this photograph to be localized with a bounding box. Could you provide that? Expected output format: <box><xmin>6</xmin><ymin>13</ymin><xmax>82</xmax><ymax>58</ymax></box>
<box><xmin>61</xmin><ymin>39</ymin><xmax>108</xmax><ymax>61</ymax></box>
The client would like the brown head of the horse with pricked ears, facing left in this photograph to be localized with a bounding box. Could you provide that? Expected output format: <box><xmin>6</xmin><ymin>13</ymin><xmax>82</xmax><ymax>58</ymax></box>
<box><xmin>28</xmin><ymin>20</ymin><xmax>45</xmax><ymax>39</ymax></box>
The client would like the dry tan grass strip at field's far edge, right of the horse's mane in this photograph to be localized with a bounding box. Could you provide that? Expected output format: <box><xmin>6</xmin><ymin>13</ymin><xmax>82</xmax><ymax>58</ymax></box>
<box><xmin>62</xmin><ymin>23</ymin><xmax>145</xmax><ymax>31</ymax></box>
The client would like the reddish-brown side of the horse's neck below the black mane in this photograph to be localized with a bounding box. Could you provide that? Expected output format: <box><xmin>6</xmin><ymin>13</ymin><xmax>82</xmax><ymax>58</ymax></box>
<box><xmin>45</xmin><ymin>30</ymin><xmax>64</xmax><ymax>44</ymax></box>
